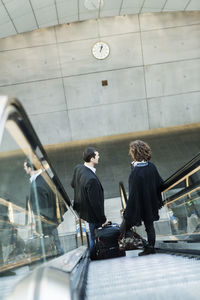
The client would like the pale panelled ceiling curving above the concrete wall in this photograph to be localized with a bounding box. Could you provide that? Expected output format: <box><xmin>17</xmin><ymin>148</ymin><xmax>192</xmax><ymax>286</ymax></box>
<box><xmin>0</xmin><ymin>0</ymin><xmax>200</xmax><ymax>38</ymax></box>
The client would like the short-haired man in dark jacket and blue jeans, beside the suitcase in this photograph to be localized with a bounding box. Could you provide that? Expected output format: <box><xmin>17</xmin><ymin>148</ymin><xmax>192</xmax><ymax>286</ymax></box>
<box><xmin>71</xmin><ymin>147</ymin><xmax>108</xmax><ymax>259</ymax></box>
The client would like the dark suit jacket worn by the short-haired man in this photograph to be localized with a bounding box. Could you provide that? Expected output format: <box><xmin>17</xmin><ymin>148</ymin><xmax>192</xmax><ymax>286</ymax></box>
<box><xmin>71</xmin><ymin>165</ymin><xmax>106</xmax><ymax>224</ymax></box>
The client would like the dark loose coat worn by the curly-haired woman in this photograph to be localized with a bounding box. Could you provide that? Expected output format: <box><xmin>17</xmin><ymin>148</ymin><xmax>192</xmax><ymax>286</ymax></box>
<box><xmin>124</xmin><ymin>162</ymin><xmax>163</xmax><ymax>226</ymax></box>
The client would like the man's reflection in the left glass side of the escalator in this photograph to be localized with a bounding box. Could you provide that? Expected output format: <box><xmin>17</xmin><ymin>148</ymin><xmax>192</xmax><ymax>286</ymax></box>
<box><xmin>24</xmin><ymin>159</ymin><xmax>64</xmax><ymax>255</ymax></box>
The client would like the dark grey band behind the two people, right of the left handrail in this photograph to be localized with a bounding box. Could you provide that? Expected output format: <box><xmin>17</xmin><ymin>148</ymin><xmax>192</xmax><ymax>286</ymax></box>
<box><xmin>46</xmin><ymin>127</ymin><xmax>200</xmax><ymax>199</ymax></box>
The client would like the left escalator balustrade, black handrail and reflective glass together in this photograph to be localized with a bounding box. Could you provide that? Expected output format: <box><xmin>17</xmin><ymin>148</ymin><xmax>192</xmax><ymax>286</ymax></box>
<box><xmin>0</xmin><ymin>96</ymin><xmax>86</xmax><ymax>299</ymax></box>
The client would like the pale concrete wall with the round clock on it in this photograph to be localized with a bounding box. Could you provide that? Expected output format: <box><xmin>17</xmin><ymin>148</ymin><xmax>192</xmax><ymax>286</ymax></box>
<box><xmin>0</xmin><ymin>11</ymin><xmax>200</xmax><ymax>145</ymax></box>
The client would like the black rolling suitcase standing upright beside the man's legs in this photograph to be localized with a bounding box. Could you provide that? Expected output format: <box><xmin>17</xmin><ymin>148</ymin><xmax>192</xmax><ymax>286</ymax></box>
<box><xmin>95</xmin><ymin>223</ymin><xmax>125</xmax><ymax>259</ymax></box>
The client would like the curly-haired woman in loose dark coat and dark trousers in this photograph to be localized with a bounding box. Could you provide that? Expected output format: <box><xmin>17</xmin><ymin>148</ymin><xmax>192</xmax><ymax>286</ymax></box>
<box><xmin>124</xmin><ymin>140</ymin><xmax>163</xmax><ymax>256</ymax></box>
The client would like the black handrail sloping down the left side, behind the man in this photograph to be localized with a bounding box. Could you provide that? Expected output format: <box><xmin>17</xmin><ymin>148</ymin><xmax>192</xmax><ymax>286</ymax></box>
<box><xmin>0</xmin><ymin>96</ymin><xmax>72</xmax><ymax>211</ymax></box>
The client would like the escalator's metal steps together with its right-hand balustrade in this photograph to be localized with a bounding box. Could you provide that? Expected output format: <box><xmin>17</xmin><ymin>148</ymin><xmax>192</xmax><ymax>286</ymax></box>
<box><xmin>86</xmin><ymin>162</ymin><xmax>200</xmax><ymax>300</ymax></box>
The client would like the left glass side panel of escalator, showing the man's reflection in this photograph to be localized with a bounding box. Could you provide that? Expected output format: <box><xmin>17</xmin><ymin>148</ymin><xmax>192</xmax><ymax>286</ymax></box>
<box><xmin>0</xmin><ymin>121</ymin><xmax>77</xmax><ymax>272</ymax></box>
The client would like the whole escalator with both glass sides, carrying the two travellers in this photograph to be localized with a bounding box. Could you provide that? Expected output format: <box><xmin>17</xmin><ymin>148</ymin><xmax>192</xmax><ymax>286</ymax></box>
<box><xmin>0</xmin><ymin>97</ymin><xmax>200</xmax><ymax>300</ymax></box>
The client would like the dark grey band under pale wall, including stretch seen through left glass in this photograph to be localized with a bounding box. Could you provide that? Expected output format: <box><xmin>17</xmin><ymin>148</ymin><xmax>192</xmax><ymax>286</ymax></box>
<box><xmin>0</xmin><ymin>123</ymin><xmax>200</xmax><ymax>203</ymax></box>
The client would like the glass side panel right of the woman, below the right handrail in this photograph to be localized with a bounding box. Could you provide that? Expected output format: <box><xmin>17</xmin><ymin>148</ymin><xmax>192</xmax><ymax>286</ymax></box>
<box><xmin>157</xmin><ymin>167</ymin><xmax>200</xmax><ymax>242</ymax></box>
